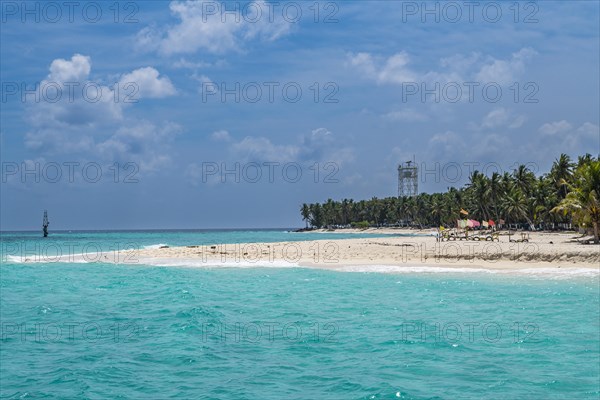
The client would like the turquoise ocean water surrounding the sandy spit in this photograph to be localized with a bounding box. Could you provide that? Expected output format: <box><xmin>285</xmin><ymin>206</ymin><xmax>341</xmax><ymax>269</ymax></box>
<box><xmin>0</xmin><ymin>231</ymin><xmax>600</xmax><ymax>399</ymax></box>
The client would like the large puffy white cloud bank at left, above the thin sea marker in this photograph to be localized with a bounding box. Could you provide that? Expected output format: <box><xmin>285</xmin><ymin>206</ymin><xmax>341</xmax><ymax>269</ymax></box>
<box><xmin>25</xmin><ymin>54</ymin><xmax>179</xmax><ymax>171</ymax></box>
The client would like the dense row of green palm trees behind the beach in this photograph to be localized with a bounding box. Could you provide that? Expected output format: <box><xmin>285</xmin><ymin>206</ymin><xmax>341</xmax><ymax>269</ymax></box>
<box><xmin>300</xmin><ymin>154</ymin><xmax>600</xmax><ymax>240</ymax></box>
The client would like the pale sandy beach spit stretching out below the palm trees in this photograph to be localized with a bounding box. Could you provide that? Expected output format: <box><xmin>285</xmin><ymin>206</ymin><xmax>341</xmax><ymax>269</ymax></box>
<box><xmin>125</xmin><ymin>230</ymin><xmax>600</xmax><ymax>274</ymax></box>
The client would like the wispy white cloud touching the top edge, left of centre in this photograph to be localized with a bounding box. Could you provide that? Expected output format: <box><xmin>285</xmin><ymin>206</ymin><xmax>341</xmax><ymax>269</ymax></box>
<box><xmin>137</xmin><ymin>0</ymin><xmax>291</xmax><ymax>55</ymax></box>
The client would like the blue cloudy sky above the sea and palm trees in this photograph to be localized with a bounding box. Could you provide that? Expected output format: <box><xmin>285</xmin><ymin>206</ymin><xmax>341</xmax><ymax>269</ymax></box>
<box><xmin>0</xmin><ymin>1</ymin><xmax>600</xmax><ymax>230</ymax></box>
